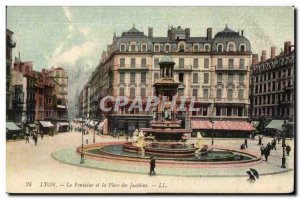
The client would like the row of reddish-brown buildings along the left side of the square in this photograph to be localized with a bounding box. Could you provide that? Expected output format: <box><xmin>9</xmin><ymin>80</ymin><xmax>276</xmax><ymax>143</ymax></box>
<box><xmin>6</xmin><ymin>30</ymin><xmax>69</xmax><ymax>137</ymax></box>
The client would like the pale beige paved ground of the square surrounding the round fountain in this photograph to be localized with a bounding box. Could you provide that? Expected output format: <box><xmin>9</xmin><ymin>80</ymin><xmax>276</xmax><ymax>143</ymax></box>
<box><xmin>7</xmin><ymin>132</ymin><xmax>294</xmax><ymax>193</ymax></box>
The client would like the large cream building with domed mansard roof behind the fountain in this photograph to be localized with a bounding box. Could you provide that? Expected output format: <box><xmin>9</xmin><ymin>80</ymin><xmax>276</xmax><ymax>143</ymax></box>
<box><xmin>79</xmin><ymin>26</ymin><xmax>252</xmax><ymax>136</ymax></box>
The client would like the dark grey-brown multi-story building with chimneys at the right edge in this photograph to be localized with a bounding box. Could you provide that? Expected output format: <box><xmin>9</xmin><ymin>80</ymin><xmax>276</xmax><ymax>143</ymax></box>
<box><xmin>250</xmin><ymin>42</ymin><xmax>295</xmax><ymax>121</ymax></box>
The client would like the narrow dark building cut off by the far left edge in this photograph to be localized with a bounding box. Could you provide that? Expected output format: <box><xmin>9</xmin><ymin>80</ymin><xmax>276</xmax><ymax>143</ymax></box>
<box><xmin>6</xmin><ymin>29</ymin><xmax>16</xmax><ymax>120</ymax></box>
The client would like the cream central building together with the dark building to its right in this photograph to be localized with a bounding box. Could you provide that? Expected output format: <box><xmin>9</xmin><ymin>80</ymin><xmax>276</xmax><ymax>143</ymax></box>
<box><xmin>78</xmin><ymin>25</ymin><xmax>294</xmax><ymax>137</ymax></box>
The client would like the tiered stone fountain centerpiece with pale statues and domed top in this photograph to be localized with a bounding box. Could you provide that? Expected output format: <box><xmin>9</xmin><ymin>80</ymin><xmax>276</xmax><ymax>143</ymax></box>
<box><xmin>123</xmin><ymin>56</ymin><xmax>204</xmax><ymax>157</ymax></box>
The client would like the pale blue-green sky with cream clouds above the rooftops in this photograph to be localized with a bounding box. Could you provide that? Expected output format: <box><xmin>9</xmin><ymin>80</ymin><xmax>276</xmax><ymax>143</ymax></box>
<box><xmin>7</xmin><ymin>6</ymin><xmax>294</xmax><ymax>70</ymax></box>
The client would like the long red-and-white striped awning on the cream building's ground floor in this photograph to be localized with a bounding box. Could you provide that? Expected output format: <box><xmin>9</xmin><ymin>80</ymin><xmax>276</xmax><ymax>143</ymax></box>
<box><xmin>191</xmin><ymin>120</ymin><xmax>255</xmax><ymax>131</ymax></box>
